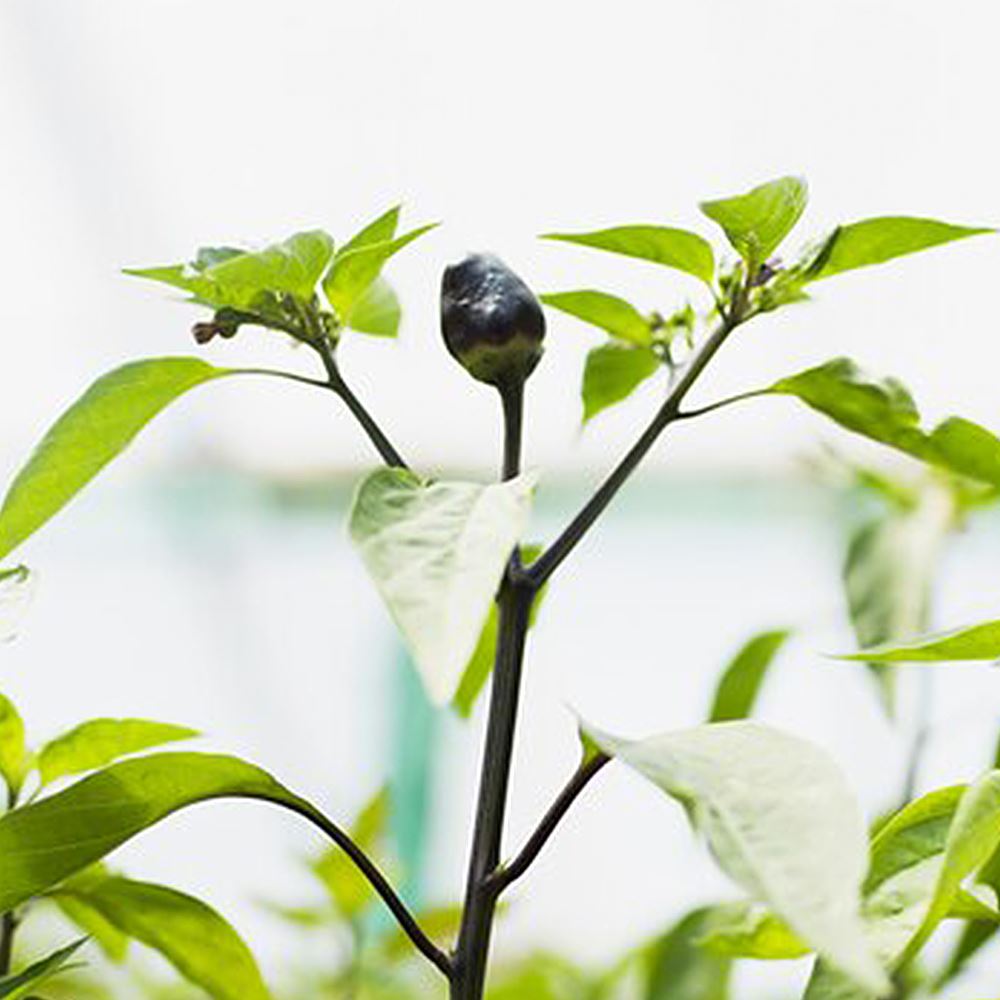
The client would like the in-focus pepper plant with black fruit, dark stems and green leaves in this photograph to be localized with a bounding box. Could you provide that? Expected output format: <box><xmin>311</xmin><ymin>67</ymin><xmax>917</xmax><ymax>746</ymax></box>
<box><xmin>0</xmin><ymin>177</ymin><xmax>1000</xmax><ymax>1000</ymax></box>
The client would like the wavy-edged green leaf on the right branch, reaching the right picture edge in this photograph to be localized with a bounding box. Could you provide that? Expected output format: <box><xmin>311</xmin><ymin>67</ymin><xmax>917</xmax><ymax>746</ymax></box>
<box><xmin>768</xmin><ymin>358</ymin><xmax>1000</xmax><ymax>486</ymax></box>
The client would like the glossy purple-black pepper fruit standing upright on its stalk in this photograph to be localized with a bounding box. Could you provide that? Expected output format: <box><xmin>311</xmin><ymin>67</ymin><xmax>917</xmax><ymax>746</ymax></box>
<box><xmin>441</xmin><ymin>254</ymin><xmax>545</xmax><ymax>389</ymax></box>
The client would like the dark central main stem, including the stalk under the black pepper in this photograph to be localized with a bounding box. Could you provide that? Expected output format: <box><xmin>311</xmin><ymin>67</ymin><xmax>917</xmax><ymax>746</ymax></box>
<box><xmin>451</xmin><ymin>384</ymin><xmax>536</xmax><ymax>1000</ymax></box>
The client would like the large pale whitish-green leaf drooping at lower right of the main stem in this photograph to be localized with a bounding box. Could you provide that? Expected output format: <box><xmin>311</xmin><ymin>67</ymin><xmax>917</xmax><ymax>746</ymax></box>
<box><xmin>591</xmin><ymin>722</ymin><xmax>889</xmax><ymax>995</ymax></box>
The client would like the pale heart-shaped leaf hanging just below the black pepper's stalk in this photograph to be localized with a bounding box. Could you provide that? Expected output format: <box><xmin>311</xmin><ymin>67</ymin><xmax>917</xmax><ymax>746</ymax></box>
<box><xmin>350</xmin><ymin>469</ymin><xmax>534</xmax><ymax>705</ymax></box>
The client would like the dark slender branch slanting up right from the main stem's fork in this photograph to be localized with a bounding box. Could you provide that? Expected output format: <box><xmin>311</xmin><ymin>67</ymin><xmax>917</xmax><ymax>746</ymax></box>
<box><xmin>527</xmin><ymin>302</ymin><xmax>746</xmax><ymax>586</ymax></box>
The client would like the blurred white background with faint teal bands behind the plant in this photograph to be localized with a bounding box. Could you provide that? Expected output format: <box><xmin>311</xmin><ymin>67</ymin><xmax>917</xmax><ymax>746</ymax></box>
<box><xmin>0</xmin><ymin>0</ymin><xmax>1000</xmax><ymax>997</ymax></box>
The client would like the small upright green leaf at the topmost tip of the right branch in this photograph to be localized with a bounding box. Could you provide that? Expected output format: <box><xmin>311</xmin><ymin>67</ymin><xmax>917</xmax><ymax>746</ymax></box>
<box><xmin>701</xmin><ymin>177</ymin><xmax>809</xmax><ymax>270</ymax></box>
